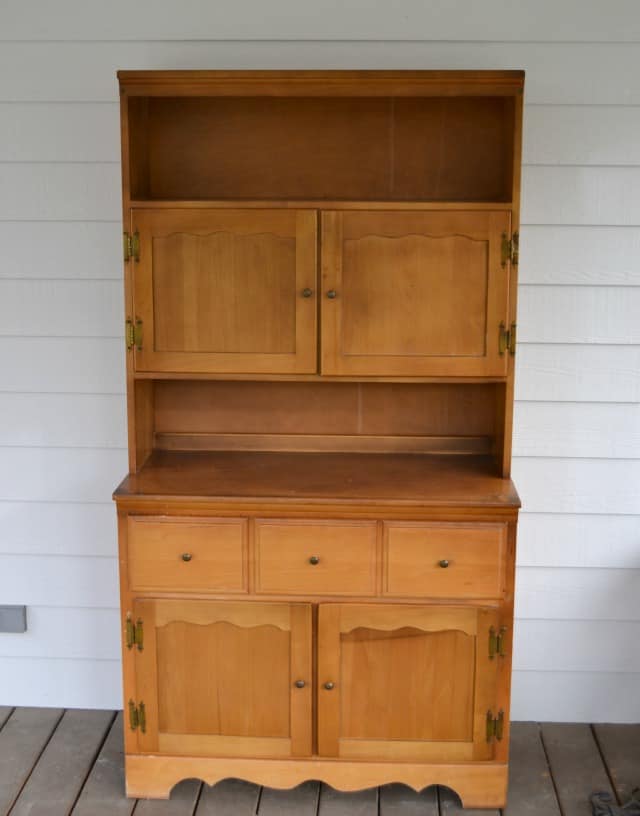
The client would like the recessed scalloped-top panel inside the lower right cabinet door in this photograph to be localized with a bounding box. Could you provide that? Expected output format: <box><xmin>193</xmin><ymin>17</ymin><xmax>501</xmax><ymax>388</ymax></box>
<box><xmin>340</xmin><ymin>627</ymin><xmax>475</xmax><ymax>742</ymax></box>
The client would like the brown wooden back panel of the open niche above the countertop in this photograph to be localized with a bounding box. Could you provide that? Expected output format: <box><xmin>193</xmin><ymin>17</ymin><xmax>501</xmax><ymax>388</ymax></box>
<box><xmin>154</xmin><ymin>380</ymin><xmax>496</xmax><ymax>452</ymax></box>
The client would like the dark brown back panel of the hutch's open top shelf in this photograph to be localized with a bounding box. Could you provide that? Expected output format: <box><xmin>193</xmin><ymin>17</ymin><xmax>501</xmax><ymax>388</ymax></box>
<box><xmin>129</xmin><ymin>97</ymin><xmax>514</xmax><ymax>201</ymax></box>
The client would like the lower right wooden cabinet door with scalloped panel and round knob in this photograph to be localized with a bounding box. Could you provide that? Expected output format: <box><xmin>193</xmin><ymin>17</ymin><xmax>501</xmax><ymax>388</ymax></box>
<box><xmin>318</xmin><ymin>604</ymin><xmax>500</xmax><ymax>762</ymax></box>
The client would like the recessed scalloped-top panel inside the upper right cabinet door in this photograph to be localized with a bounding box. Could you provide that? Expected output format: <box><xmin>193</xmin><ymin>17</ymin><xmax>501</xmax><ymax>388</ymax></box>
<box><xmin>342</xmin><ymin>234</ymin><xmax>489</xmax><ymax>357</ymax></box>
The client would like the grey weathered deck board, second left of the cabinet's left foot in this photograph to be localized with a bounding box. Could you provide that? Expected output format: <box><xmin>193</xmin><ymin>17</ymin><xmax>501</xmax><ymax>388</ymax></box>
<box><xmin>8</xmin><ymin>709</ymin><xmax>114</xmax><ymax>816</ymax></box>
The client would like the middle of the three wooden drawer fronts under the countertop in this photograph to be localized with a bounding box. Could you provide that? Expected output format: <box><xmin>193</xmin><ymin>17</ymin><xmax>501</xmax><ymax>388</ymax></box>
<box><xmin>256</xmin><ymin>519</ymin><xmax>376</xmax><ymax>595</ymax></box>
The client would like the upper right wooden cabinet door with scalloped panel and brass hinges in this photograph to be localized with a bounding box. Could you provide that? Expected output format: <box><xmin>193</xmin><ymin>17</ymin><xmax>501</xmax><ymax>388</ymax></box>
<box><xmin>321</xmin><ymin>210</ymin><xmax>511</xmax><ymax>377</ymax></box>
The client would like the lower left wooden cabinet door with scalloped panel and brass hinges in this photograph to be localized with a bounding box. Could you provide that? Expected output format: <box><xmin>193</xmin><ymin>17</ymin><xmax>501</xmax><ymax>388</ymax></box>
<box><xmin>128</xmin><ymin>600</ymin><xmax>313</xmax><ymax>757</ymax></box>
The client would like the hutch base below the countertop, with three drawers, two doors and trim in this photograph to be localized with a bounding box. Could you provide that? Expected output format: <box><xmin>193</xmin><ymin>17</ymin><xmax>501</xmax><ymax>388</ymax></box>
<box><xmin>121</xmin><ymin>513</ymin><xmax>515</xmax><ymax>808</ymax></box>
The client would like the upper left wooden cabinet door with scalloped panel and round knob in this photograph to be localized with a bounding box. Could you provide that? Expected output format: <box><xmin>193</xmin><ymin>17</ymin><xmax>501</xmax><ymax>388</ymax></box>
<box><xmin>129</xmin><ymin>209</ymin><xmax>317</xmax><ymax>374</ymax></box>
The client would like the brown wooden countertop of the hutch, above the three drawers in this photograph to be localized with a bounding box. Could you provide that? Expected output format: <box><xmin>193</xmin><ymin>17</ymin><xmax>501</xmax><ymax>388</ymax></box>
<box><xmin>114</xmin><ymin>451</ymin><xmax>520</xmax><ymax>510</ymax></box>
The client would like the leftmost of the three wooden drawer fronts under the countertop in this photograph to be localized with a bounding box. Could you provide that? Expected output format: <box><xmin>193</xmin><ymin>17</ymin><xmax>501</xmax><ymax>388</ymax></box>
<box><xmin>128</xmin><ymin>516</ymin><xmax>247</xmax><ymax>592</ymax></box>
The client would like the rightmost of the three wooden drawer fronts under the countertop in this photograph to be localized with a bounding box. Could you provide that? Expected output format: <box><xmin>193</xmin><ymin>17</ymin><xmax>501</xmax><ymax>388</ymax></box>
<box><xmin>383</xmin><ymin>522</ymin><xmax>507</xmax><ymax>598</ymax></box>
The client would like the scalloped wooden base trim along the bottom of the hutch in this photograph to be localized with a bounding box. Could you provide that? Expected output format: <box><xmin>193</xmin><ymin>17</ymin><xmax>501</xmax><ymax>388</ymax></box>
<box><xmin>125</xmin><ymin>754</ymin><xmax>508</xmax><ymax>808</ymax></box>
